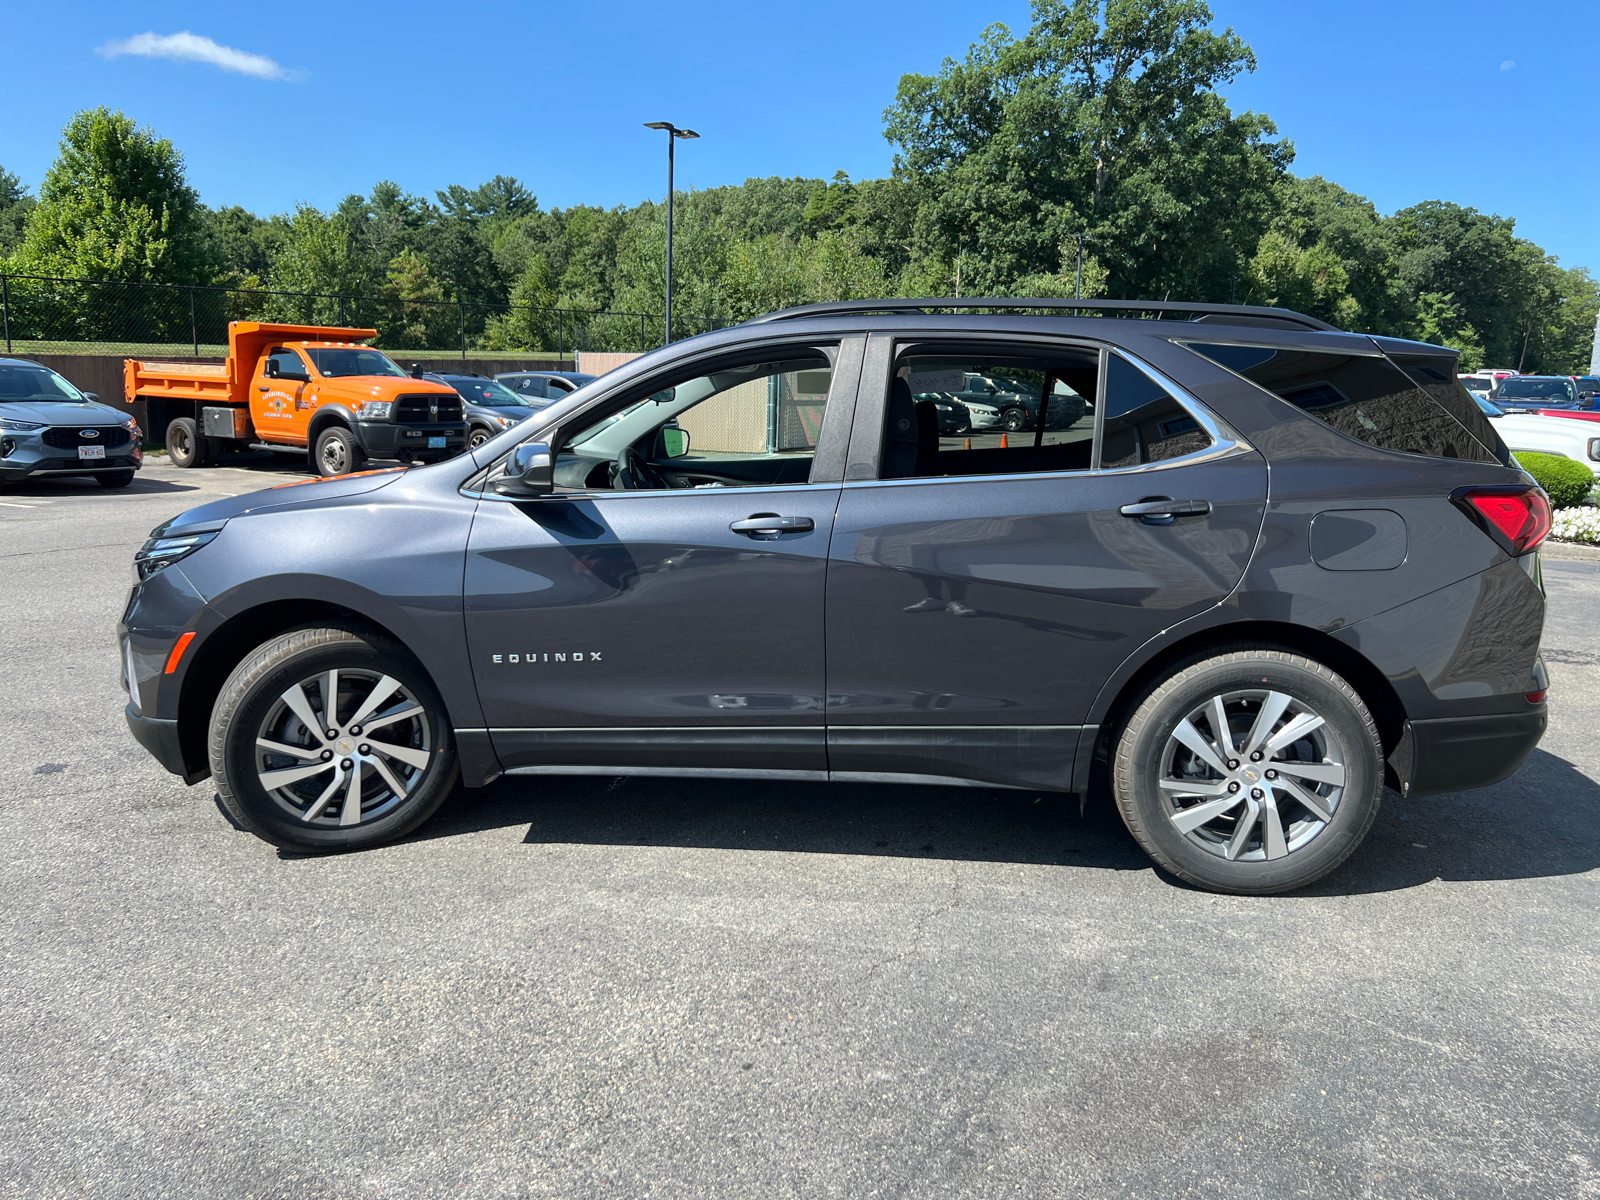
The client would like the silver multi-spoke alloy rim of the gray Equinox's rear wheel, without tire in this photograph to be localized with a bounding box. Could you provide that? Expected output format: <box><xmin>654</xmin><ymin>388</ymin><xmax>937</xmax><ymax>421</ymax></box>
<box><xmin>1157</xmin><ymin>688</ymin><xmax>1347</xmax><ymax>862</ymax></box>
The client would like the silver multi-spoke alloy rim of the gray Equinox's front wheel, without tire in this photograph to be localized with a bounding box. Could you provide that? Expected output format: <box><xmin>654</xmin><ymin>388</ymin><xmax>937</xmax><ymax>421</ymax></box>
<box><xmin>254</xmin><ymin>669</ymin><xmax>432</xmax><ymax>829</ymax></box>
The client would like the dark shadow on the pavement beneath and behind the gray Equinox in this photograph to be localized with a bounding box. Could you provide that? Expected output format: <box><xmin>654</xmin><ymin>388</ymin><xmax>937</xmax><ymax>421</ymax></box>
<box><xmin>413</xmin><ymin>750</ymin><xmax>1600</xmax><ymax>896</ymax></box>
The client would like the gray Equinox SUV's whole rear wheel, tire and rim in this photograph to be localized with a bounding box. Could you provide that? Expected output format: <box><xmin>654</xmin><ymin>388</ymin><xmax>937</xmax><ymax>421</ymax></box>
<box><xmin>1112</xmin><ymin>648</ymin><xmax>1384</xmax><ymax>894</ymax></box>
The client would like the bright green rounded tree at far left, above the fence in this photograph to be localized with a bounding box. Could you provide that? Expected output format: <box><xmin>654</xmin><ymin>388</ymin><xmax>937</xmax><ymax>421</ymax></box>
<box><xmin>14</xmin><ymin>107</ymin><xmax>214</xmax><ymax>283</ymax></box>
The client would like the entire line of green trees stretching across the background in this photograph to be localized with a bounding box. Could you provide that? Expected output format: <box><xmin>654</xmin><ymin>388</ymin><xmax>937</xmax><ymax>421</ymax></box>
<box><xmin>0</xmin><ymin>0</ymin><xmax>1600</xmax><ymax>373</ymax></box>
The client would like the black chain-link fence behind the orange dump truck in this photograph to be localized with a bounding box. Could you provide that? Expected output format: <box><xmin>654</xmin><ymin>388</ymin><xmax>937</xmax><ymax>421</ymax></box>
<box><xmin>0</xmin><ymin>274</ymin><xmax>722</xmax><ymax>358</ymax></box>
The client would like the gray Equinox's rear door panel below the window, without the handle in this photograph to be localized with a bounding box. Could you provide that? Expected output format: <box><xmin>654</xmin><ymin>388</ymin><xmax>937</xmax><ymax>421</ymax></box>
<box><xmin>827</xmin><ymin>451</ymin><xmax>1266</xmax><ymax>787</ymax></box>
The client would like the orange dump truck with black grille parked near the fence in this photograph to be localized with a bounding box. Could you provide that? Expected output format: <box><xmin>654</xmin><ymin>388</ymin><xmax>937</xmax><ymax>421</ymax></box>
<box><xmin>123</xmin><ymin>322</ymin><xmax>467</xmax><ymax>475</ymax></box>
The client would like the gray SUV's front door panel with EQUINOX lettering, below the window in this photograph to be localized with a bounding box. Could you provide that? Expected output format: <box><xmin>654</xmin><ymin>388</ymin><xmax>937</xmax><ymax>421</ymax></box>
<box><xmin>466</xmin><ymin>485</ymin><xmax>838</xmax><ymax>770</ymax></box>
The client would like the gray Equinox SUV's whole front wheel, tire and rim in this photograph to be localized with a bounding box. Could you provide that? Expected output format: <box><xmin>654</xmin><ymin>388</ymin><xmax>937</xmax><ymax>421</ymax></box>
<box><xmin>210</xmin><ymin>629</ymin><xmax>456</xmax><ymax>853</ymax></box>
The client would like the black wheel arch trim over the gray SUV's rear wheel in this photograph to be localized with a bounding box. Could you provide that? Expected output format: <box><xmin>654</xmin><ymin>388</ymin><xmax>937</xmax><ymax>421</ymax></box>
<box><xmin>1074</xmin><ymin>621</ymin><xmax>1406</xmax><ymax>792</ymax></box>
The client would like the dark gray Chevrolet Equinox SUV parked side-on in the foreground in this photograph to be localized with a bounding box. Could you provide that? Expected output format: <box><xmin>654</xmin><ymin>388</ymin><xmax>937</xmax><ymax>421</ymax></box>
<box><xmin>118</xmin><ymin>299</ymin><xmax>1550</xmax><ymax>893</ymax></box>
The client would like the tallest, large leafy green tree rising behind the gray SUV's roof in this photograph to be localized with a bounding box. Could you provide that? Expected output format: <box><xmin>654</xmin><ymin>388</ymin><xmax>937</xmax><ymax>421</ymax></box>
<box><xmin>885</xmin><ymin>0</ymin><xmax>1293</xmax><ymax>299</ymax></box>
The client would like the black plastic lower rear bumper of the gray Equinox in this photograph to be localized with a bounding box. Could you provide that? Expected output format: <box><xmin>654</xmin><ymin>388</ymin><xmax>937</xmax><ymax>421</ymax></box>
<box><xmin>1389</xmin><ymin>704</ymin><xmax>1549</xmax><ymax>797</ymax></box>
